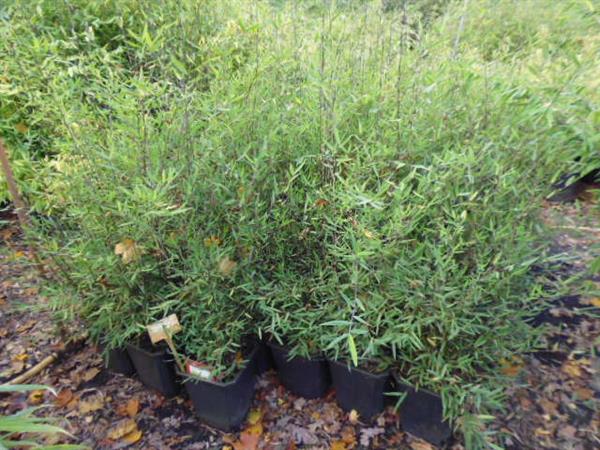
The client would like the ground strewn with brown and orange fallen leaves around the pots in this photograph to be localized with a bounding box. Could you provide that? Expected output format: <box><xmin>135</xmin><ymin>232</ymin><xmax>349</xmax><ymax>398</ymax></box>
<box><xmin>0</xmin><ymin>204</ymin><xmax>600</xmax><ymax>450</ymax></box>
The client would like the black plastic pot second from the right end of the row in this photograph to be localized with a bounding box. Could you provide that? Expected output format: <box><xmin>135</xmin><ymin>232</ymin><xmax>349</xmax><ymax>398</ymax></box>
<box><xmin>329</xmin><ymin>361</ymin><xmax>390</xmax><ymax>419</ymax></box>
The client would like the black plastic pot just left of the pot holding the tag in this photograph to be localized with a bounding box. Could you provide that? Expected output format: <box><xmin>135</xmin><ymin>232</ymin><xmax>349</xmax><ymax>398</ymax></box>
<box><xmin>127</xmin><ymin>344</ymin><xmax>180</xmax><ymax>397</ymax></box>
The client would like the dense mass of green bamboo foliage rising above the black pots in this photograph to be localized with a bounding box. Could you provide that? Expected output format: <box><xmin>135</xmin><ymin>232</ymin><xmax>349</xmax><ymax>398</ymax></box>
<box><xmin>0</xmin><ymin>0</ymin><xmax>599</xmax><ymax>448</ymax></box>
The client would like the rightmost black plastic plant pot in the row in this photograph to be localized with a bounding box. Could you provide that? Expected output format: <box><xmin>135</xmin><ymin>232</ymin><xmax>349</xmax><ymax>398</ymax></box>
<box><xmin>396</xmin><ymin>379</ymin><xmax>452</xmax><ymax>447</ymax></box>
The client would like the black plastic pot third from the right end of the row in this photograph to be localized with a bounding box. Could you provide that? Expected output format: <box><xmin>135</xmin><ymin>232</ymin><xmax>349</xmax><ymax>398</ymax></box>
<box><xmin>269</xmin><ymin>343</ymin><xmax>331</xmax><ymax>399</ymax></box>
